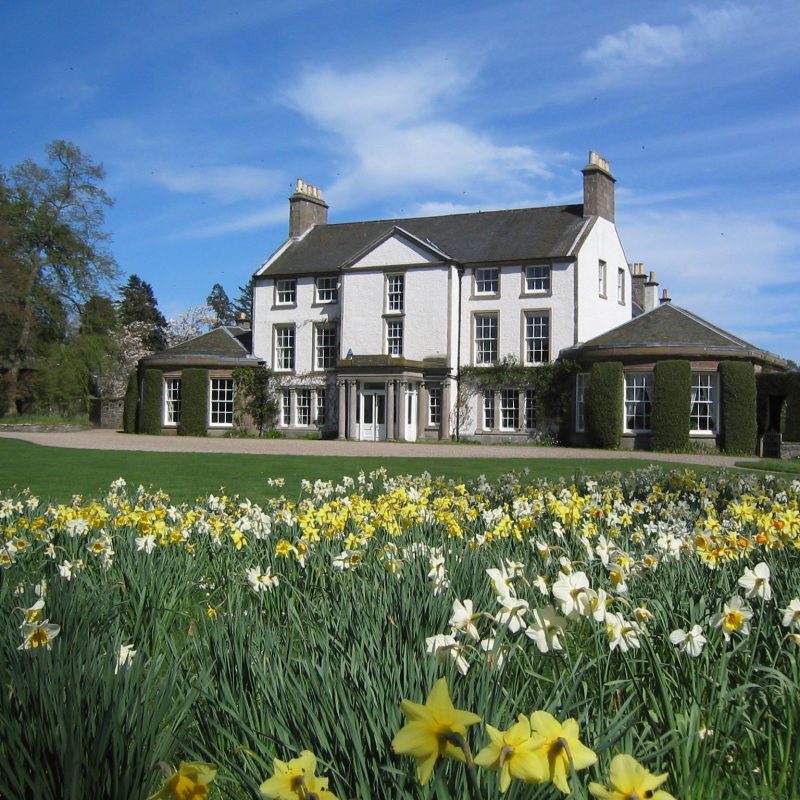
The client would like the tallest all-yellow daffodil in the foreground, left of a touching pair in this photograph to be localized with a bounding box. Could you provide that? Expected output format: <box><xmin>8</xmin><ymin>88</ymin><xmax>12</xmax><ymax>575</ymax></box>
<box><xmin>392</xmin><ymin>678</ymin><xmax>481</xmax><ymax>786</ymax></box>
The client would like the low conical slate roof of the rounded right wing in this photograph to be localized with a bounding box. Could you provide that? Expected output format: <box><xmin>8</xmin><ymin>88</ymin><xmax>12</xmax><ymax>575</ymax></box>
<box><xmin>561</xmin><ymin>303</ymin><xmax>785</xmax><ymax>367</ymax></box>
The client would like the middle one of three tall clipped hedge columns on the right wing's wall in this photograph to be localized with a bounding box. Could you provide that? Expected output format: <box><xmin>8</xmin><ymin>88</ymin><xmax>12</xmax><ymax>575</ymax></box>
<box><xmin>650</xmin><ymin>359</ymin><xmax>692</xmax><ymax>452</ymax></box>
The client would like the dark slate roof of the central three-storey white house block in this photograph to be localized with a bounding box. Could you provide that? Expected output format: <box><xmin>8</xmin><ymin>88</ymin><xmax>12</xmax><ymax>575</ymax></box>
<box><xmin>257</xmin><ymin>205</ymin><xmax>591</xmax><ymax>275</ymax></box>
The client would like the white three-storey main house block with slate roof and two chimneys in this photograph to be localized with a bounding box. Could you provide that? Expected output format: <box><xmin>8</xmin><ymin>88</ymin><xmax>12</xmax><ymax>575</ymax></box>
<box><xmin>252</xmin><ymin>152</ymin><xmax>633</xmax><ymax>441</ymax></box>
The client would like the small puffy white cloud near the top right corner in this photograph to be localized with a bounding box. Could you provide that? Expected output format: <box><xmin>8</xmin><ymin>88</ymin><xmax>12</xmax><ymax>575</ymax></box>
<box><xmin>582</xmin><ymin>6</ymin><xmax>749</xmax><ymax>74</ymax></box>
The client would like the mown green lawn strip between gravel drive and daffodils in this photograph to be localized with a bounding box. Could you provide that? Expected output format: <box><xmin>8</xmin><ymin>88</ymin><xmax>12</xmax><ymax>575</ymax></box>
<box><xmin>0</xmin><ymin>439</ymin><xmax>708</xmax><ymax>503</ymax></box>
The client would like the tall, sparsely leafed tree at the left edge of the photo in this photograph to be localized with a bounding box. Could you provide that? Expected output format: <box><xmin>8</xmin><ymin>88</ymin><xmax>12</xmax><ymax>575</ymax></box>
<box><xmin>0</xmin><ymin>140</ymin><xmax>117</xmax><ymax>416</ymax></box>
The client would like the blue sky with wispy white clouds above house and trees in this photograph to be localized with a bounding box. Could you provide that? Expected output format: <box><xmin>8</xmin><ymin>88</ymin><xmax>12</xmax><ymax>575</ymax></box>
<box><xmin>6</xmin><ymin>0</ymin><xmax>800</xmax><ymax>361</ymax></box>
